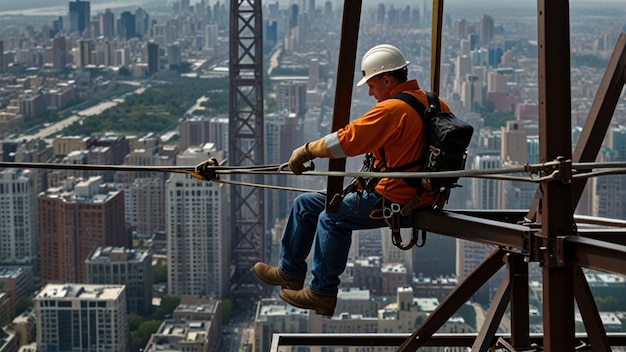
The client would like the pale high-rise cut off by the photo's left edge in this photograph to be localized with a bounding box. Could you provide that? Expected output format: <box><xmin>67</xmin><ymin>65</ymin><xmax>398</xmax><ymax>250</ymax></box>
<box><xmin>0</xmin><ymin>168</ymin><xmax>39</xmax><ymax>264</ymax></box>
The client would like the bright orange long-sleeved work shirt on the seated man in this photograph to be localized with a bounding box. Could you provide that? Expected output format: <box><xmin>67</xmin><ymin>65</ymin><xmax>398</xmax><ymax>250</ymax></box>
<box><xmin>325</xmin><ymin>80</ymin><xmax>450</xmax><ymax>206</ymax></box>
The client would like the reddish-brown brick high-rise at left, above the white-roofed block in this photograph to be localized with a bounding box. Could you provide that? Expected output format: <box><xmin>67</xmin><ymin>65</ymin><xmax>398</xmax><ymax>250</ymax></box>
<box><xmin>39</xmin><ymin>176</ymin><xmax>129</xmax><ymax>283</ymax></box>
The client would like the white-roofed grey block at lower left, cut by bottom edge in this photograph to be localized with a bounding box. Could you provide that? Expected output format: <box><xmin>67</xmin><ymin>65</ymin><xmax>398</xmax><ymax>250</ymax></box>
<box><xmin>35</xmin><ymin>283</ymin><xmax>130</xmax><ymax>352</ymax></box>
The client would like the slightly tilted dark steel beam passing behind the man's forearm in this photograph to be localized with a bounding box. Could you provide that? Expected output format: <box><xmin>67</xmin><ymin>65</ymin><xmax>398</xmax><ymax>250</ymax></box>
<box><xmin>326</xmin><ymin>0</ymin><xmax>362</xmax><ymax>212</ymax></box>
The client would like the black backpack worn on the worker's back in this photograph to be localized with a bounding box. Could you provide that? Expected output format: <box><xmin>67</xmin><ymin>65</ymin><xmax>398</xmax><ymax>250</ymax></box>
<box><xmin>387</xmin><ymin>92</ymin><xmax>474</xmax><ymax>192</ymax></box>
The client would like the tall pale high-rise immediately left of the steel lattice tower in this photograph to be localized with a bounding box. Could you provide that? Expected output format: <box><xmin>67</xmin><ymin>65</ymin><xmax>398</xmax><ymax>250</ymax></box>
<box><xmin>165</xmin><ymin>143</ymin><xmax>229</xmax><ymax>298</ymax></box>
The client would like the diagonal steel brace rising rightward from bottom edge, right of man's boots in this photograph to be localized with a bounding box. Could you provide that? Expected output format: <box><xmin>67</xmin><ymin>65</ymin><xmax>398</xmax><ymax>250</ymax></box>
<box><xmin>398</xmin><ymin>249</ymin><xmax>506</xmax><ymax>352</ymax></box>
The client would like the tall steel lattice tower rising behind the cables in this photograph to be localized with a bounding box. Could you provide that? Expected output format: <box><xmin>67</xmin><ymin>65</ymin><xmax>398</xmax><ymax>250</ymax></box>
<box><xmin>228</xmin><ymin>0</ymin><xmax>265</xmax><ymax>295</ymax></box>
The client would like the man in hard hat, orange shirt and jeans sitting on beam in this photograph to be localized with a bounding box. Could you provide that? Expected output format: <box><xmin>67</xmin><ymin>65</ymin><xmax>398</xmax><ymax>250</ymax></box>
<box><xmin>252</xmin><ymin>44</ymin><xmax>449</xmax><ymax>315</ymax></box>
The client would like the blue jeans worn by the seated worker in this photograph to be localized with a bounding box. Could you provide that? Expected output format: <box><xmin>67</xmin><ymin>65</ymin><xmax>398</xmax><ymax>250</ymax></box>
<box><xmin>278</xmin><ymin>191</ymin><xmax>411</xmax><ymax>295</ymax></box>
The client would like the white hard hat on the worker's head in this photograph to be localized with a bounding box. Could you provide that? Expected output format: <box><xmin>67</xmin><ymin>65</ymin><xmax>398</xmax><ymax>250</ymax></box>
<box><xmin>356</xmin><ymin>44</ymin><xmax>409</xmax><ymax>86</ymax></box>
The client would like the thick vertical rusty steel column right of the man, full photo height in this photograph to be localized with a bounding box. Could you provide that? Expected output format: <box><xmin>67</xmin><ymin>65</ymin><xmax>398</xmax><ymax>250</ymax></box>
<box><xmin>537</xmin><ymin>0</ymin><xmax>575</xmax><ymax>352</ymax></box>
